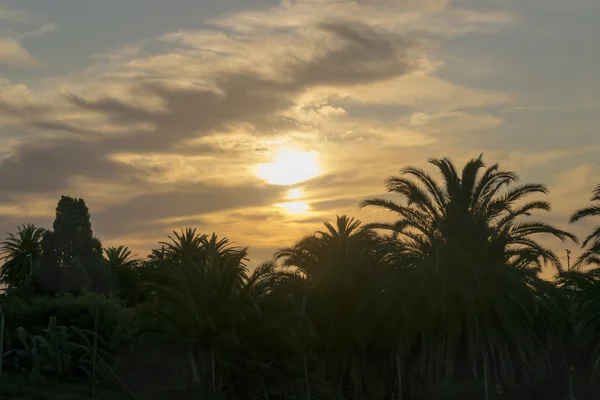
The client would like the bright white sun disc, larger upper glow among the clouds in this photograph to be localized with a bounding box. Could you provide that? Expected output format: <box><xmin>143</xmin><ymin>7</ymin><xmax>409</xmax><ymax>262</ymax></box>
<box><xmin>255</xmin><ymin>149</ymin><xmax>321</xmax><ymax>185</ymax></box>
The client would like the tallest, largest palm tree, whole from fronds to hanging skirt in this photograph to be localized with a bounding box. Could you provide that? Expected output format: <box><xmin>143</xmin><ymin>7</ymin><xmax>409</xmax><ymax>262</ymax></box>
<box><xmin>361</xmin><ymin>156</ymin><xmax>576</xmax><ymax>392</ymax></box>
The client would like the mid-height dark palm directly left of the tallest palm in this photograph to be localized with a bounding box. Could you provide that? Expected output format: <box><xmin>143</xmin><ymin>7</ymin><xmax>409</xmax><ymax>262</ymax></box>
<box><xmin>275</xmin><ymin>215</ymin><xmax>385</xmax><ymax>398</ymax></box>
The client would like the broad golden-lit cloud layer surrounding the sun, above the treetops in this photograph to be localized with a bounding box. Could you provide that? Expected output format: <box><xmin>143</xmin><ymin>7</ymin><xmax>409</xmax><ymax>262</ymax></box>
<box><xmin>0</xmin><ymin>0</ymin><xmax>524</xmax><ymax>260</ymax></box>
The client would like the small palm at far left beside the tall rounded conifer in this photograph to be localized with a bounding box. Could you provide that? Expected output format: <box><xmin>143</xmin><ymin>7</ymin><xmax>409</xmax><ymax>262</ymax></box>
<box><xmin>0</xmin><ymin>224</ymin><xmax>46</xmax><ymax>288</ymax></box>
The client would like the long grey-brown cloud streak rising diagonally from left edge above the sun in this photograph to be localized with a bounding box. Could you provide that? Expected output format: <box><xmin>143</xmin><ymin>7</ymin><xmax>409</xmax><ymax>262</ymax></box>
<box><xmin>0</xmin><ymin>16</ymin><xmax>432</xmax><ymax>190</ymax></box>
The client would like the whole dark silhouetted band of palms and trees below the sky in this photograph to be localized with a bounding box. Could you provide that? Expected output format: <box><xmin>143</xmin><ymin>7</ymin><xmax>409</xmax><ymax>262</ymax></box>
<box><xmin>0</xmin><ymin>157</ymin><xmax>600</xmax><ymax>400</ymax></box>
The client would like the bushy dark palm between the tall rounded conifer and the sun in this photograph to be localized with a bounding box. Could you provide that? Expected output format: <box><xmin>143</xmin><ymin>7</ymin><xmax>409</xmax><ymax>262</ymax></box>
<box><xmin>141</xmin><ymin>228</ymin><xmax>262</xmax><ymax>394</ymax></box>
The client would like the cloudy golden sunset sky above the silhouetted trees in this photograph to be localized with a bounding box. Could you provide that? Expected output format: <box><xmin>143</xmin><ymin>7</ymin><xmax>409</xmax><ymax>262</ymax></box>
<box><xmin>0</xmin><ymin>0</ymin><xmax>600</xmax><ymax>274</ymax></box>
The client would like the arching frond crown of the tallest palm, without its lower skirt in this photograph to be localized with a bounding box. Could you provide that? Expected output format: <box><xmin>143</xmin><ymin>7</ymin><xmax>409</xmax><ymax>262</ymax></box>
<box><xmin>361</xmin><ymin>156</ymin><xmax>577</xmax><ymax>269</ymax></box>
